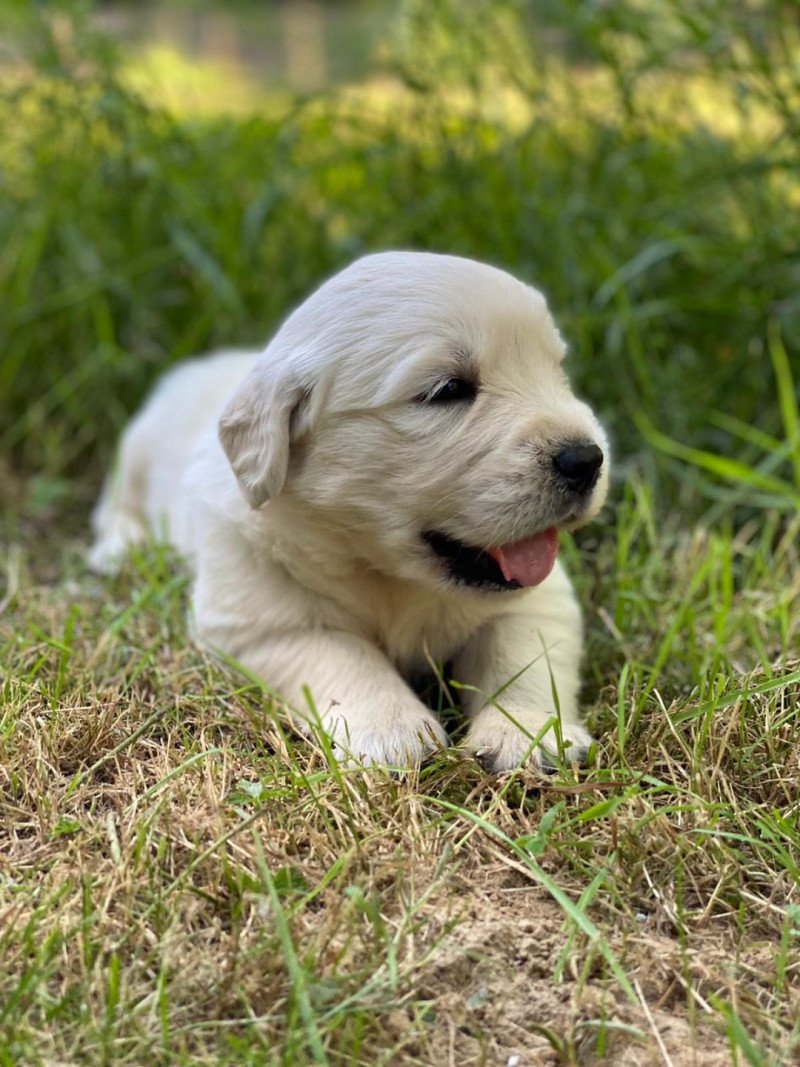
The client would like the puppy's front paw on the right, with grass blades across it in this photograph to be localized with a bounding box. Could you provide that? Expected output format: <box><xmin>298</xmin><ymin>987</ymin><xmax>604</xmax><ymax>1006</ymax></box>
<box><xmin>464</xmin><ymin>707</ymin><xmax>594</xmax><ymax>774</ymax></box>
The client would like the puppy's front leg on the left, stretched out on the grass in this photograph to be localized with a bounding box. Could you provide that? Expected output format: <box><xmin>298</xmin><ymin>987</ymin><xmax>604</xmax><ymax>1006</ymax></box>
<box><xmin>199</xmin><ymin>627</ymin><xmax>448</xmax><ymax>766</ymax></box>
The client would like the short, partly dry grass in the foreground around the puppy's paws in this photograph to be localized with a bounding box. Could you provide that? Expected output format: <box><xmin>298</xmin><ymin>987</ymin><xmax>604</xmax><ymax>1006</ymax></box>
<box><xmin>0</xmin><ymin>487</ymin><xmax>800</xmax><ymax>1064</ymax></box>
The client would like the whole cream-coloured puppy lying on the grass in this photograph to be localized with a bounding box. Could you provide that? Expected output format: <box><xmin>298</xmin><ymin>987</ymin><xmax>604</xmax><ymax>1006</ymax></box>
<box><xmin>90</xmin><ymin>252</ymin><xmax>608</xmax><ymax>771</ymax></box>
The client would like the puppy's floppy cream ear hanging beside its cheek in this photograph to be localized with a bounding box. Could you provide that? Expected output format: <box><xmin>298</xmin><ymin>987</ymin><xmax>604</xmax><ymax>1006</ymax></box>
<box><xmin>219</xmin><ymin>366</ymin><xmax>308</xmax><ymax>508</ymax></box>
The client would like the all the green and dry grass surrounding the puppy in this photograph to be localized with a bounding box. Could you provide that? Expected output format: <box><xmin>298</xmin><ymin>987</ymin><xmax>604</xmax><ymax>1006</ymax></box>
<box><xmin>0</xmin><ymin>0</ymin><xmax>800</xmax><ymax>1067</ymax></box>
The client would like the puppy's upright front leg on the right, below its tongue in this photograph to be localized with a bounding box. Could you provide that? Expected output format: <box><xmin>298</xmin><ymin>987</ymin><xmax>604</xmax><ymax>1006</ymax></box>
<box><xmin>453</xmin><ymin>569</ymin><xmax>592</xmax><ymax>771</ymax></box>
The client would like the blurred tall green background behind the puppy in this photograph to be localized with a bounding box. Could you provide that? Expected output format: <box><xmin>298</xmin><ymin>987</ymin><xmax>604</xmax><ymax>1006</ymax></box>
<box><xmin>0</xmin><ymin>0</ymin><xmax>800</xmax><ymax>517</ymax></box>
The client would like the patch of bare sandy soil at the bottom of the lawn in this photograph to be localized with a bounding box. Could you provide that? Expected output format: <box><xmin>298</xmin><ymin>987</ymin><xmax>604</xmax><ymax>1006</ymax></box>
<box><xmin>396</xmin><ymin>885</ymin><xmax>731</xmax><ymax>1067</ymax></box>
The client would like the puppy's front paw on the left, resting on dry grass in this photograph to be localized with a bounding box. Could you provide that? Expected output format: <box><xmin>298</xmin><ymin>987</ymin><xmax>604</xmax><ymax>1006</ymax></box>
<box><xmin>325</xmin><ymin>708</ymin><xmax>449</xmax><ymax>767</ymax></box>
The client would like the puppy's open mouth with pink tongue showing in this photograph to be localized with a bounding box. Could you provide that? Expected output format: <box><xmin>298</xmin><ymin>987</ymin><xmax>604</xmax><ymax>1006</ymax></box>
<box><xmin>422</xmin><ymin>526</ymin><xmax>558</xmax><ymax>590</ymax></box>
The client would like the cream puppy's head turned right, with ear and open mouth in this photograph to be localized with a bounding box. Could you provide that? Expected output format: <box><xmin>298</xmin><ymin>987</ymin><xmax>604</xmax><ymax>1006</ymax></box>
<box><xmin>220</xmin><ymin>252</ymin><xmax>609</xmax><ymax>592</ymax></box>
